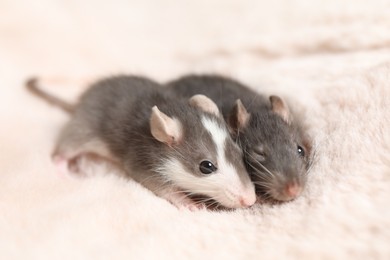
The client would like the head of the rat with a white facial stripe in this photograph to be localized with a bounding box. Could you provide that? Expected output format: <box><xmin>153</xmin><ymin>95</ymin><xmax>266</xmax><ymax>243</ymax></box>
<box><xmin>150</xmin><ymin>95</ymin><xmax>256</xmax><ymax>208</ymax></box>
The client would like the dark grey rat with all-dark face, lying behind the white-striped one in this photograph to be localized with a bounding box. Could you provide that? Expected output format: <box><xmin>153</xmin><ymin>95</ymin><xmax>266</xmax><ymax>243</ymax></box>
<box><xmin>166</xmin><ymin>75</ymin><xmax>311</xmax><ymax>201</ymax></box>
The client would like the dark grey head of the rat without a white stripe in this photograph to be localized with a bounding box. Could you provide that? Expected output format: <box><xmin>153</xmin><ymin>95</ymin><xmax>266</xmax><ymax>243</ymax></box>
<box><xmin>229</xmin><ymin>96</ymin><xmax>310</xmax><ymax>201</ymax></box>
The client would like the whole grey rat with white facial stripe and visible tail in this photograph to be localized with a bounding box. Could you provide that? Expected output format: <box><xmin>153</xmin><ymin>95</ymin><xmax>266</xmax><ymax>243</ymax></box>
<box><xmin>27</xmin><ymin>75</ymin><xmax>256</xmax><ymax>209</ymax></box>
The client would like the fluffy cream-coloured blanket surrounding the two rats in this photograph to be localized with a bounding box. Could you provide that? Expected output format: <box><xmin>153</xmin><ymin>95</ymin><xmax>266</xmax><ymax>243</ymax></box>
<box><xmin>0</xmin><ymin>0</ymin><xmax>390</xmax><ymax>259</ymax></box>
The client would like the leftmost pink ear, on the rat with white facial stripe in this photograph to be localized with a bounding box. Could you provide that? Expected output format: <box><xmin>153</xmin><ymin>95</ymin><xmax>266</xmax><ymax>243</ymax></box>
<box><xmin>150</xmin><ymin>106</ymin><xmax>182</xmax><ymax>145</ymax></box>
